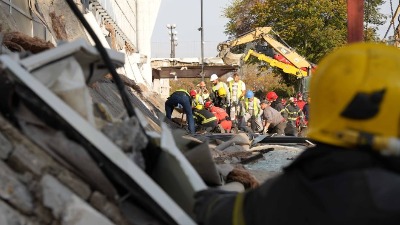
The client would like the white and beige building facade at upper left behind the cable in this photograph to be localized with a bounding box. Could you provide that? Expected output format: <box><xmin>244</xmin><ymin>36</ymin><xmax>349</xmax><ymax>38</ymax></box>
<box><xmin>0</xmin><ymin>0</ymin><xmax>161</xmax><ymax>92</ymax></box>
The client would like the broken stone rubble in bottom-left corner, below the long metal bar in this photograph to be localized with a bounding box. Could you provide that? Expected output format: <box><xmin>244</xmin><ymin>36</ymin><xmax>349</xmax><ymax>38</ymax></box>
<box><xmin>0</xmin><ymin>116</ymin><xmax>128</xmax><ymax>224</ymax></box>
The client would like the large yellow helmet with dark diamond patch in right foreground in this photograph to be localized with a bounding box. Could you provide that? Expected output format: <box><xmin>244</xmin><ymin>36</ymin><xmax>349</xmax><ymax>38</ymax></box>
<box><xmin>308</xmin><ymin>43</ymin><xmax>400</xmax><ymax>155</ymax></box>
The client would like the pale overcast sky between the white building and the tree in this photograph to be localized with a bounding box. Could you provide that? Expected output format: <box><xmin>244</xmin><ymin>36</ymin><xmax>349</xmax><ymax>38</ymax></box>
<box><xmin>152</xmin><ymin>0</ymin><xmax>398</xmax><ymax>58</ymax></box>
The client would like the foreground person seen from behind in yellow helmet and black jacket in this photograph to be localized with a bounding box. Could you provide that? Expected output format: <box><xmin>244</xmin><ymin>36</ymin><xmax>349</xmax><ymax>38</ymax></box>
<box><xmin>194</xmin><ymin>43</ymin><xmax>400</xmax><ymax>225</ymax></box>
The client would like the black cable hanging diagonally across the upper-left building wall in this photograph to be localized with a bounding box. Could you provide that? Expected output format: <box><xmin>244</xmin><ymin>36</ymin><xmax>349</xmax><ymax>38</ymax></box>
<box><xmin>66</xmin><ymin>0</ymin><xmax>136</xmax><ymax>117</ymax></box>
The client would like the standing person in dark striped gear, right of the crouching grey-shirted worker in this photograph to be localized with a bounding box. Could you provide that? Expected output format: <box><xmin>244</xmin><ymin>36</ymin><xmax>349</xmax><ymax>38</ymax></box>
<box><xmin>284</xmin><ymin>97</ymin><xmax>303</xmax><ymax>136</ymax></box>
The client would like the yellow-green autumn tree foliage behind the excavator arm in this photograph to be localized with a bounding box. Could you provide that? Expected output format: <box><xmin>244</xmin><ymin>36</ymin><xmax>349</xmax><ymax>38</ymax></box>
<box><xmin>224</xmin><ymin>0</ymin><xmax>386</xmax><ymax>92</ymax></box>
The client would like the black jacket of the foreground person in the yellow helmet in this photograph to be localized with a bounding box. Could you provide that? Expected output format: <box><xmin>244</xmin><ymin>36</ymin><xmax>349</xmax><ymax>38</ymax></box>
<box><xmin>200</xmin><ymin>144</ymin><xmax>400</xmax><ymax>225</ymax></box>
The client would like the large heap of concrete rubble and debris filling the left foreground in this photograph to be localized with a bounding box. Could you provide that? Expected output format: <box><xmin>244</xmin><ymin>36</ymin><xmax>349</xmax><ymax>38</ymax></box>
<box><xmin>0</xmin><ymin>1</ymin><xmax>303</xmax><ymax>225</ymax></box>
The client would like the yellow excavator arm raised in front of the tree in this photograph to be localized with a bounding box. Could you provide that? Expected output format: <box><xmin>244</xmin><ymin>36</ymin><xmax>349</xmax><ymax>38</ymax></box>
<box><xmin>217</xmin><ymin>27</ymin><xmax>316</xmax><ymax>78</ymax></box>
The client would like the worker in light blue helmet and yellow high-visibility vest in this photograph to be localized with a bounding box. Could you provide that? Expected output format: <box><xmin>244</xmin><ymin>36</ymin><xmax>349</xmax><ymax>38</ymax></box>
<box><xmin>239</xmin><ymin>90</ymin><xmax>262</xmax><ymax>133</ymax></box>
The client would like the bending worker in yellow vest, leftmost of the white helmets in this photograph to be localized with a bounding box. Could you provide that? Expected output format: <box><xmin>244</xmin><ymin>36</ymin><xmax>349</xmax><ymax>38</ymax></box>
<box><xmin>210</xmin><ymin>74</ymin><xmax>230</xmax><ymax>109</ymax></box>
